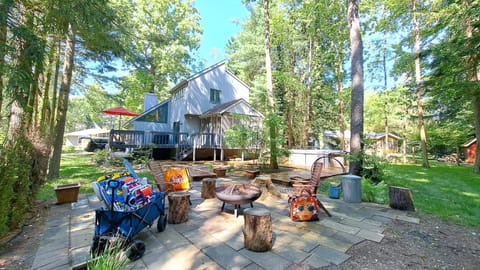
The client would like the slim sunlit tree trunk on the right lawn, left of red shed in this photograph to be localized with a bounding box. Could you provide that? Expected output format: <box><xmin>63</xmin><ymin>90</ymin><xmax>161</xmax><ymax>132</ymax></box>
<box><xmin>412</xmin><ymin>0</ymin><xmax>430</xmax><ymax>168</ymax></box>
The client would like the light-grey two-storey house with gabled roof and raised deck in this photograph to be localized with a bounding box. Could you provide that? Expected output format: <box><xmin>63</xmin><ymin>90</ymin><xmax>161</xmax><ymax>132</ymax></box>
<box><xmin>117</xmin><ymin>62</ymin><xmax>263</xmax><ymax>159</ymax></box>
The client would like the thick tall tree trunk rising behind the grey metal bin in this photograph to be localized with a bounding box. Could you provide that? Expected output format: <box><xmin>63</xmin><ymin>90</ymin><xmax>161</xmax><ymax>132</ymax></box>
<box><xmin>348</xmin><ymin>0</ymin><xmax>364</xmax><ymax>175</ymax></box>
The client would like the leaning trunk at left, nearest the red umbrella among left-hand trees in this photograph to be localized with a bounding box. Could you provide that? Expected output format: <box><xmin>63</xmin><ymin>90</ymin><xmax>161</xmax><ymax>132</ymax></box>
<box><xmin>48</xmin><ymin>24</ymin><xmax>75</xmax><ymax>179</ymax></box>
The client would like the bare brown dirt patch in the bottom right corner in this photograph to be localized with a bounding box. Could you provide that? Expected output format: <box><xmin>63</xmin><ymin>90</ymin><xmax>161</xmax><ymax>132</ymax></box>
<box><xmin>322</xmin><ymin>213</ymin><xmax>480</xmax><ymax>270</ymax></box>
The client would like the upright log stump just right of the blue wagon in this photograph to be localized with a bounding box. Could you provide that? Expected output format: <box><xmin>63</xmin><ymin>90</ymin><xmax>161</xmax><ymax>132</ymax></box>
<box><xmin>168</xmin><ymin>191</ymin><xmax>190</xmax><ymax>224</ymax></box>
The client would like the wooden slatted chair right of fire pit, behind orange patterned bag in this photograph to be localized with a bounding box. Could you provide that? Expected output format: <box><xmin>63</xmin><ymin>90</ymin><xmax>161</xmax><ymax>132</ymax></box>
<box><xmin>288</xmin><ymin>157</ymin><xmax>332</xmax><ymax>217</ymax></box>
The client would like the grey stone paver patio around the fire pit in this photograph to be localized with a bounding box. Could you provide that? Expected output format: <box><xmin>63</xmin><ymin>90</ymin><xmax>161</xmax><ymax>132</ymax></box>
<box><xmin>32</xmin><ymin>172</ymin><xmax>419</xmax><ymax>270</ymax></box>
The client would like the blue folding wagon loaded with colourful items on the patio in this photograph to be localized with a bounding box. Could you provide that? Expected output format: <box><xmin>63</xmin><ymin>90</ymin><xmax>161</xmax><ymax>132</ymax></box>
<box><xmin>91</xmin><ymin>160</ymin><xmax>167</xmax><ymax>261</ymax></box>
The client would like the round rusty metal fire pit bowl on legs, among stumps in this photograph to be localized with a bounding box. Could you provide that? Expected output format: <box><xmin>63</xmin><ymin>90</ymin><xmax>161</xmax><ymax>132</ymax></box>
<box><xmin>215</xmin><ymin>183</ymin><xmax>262</xmax><ymax>217</ymax></box>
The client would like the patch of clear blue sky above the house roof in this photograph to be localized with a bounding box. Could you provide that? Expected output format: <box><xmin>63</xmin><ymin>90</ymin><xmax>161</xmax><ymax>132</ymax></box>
<box><xmin>195</xmin><ymin>0</ymin><xmax>248</xmax><ymax>66</ymax></box>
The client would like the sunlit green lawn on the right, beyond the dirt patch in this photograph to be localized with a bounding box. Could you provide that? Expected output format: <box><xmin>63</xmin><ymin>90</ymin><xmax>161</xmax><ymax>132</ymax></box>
<box><xmin>386</xmin><ymin>162</ymin><xmax>480</xmax><ymax>226</ymax></box>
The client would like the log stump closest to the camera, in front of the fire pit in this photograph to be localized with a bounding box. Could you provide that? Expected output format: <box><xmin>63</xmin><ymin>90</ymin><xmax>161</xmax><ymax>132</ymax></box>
<box><xmin>243</xmin><ymin>208</ymin><xmax>273</xmax><ymax>251</ymax></box>
